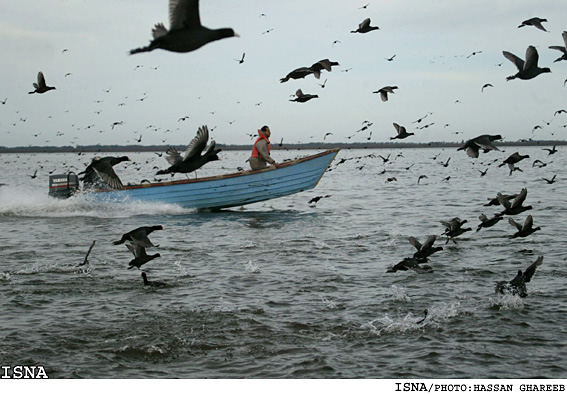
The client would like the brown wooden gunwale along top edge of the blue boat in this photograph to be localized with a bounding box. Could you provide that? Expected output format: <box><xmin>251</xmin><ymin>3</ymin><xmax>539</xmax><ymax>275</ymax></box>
<box><xmin>91</xmin><ymin>148</ymin><xmax>340</xmax><ymax>193</ymax></box>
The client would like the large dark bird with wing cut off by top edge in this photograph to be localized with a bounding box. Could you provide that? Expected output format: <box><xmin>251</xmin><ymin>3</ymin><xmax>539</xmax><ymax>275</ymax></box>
<box><xmin>130</xmin><ymin>0</ymin><xmax>239</xmax><ymax>55</ymax></box>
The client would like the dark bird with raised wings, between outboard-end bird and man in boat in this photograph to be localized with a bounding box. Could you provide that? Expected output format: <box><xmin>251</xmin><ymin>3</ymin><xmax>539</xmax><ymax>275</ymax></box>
<box><xmin>160</xmin><ymin>125</ymin><xmax>221</xmax><ymax>174</ymax></box>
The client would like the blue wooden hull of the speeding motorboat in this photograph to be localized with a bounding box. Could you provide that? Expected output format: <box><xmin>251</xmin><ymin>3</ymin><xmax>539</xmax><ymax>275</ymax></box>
<box><xmin>50</xmin><ymin>148</ymin><xmax>340</xmax><ymax>210</ymax></box>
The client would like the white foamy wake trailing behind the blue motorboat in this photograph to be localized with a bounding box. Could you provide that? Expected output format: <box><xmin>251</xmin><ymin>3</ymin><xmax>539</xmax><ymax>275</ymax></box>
<box><xmin>0</xmin><ymin>187</ymin><xmax>196</xmax><ymax>218</ymax></box>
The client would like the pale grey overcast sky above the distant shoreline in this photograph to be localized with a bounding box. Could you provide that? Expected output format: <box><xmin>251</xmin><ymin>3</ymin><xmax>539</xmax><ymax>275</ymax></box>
<box><xmin>0</xmin><ymin>0</ymin><xmax>567</xmax><ymax>147</ymax></box>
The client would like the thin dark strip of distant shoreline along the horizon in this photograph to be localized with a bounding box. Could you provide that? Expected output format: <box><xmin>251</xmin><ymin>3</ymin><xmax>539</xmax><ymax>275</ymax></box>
<box><xmin>0</xmin><ymin>140</ymin><xmax>567</xmax><ymax>153</ymax></box>
